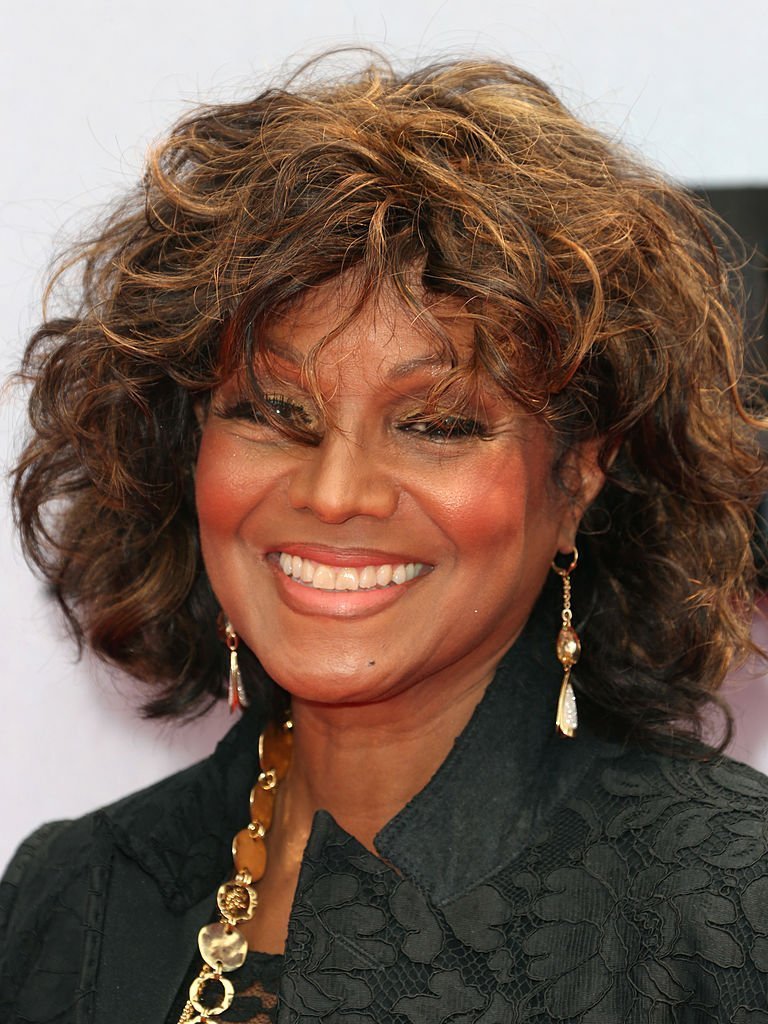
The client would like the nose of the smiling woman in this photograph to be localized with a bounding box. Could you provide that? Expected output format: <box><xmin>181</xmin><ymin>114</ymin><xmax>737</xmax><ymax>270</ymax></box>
<box><xmin>288</xmin><ymin>429</ymin><xmax>399</xmax><ymax>523</ymax></box>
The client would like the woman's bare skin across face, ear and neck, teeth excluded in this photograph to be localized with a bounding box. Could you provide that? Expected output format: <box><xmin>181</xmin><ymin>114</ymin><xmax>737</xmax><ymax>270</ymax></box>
<box><xmin>197</xmin><ymin>283</ymin><xmax>601</xmax><ymax>949</ymax></box>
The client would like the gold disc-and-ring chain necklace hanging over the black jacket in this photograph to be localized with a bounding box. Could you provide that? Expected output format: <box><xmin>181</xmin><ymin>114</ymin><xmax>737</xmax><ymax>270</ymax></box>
<box><xmin>178</xmin><ymin>720</ymin><xmax>293</xmax><ymax>1024</ymax></box>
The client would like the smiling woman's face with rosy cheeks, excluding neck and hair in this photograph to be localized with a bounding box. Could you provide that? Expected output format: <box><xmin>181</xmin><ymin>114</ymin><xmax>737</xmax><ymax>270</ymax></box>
<box><xmin>197</xmin><ymin>282</ymin><xmax>593</xmax><ymax>702</ymax></box>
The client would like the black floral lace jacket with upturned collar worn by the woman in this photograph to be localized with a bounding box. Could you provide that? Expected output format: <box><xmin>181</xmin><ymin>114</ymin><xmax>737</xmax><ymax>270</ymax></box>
<box><xmin>0</xmin><ymin>602</ymin><xmax>768</xmax><ymax>1024</ymax></box>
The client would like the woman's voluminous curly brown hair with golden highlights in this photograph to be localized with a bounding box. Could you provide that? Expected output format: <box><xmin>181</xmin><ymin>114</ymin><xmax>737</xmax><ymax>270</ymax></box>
<box><xmin>14</xmin><ymin>51</ymin><xmax>766</xmax><ymax>745</ymax></box>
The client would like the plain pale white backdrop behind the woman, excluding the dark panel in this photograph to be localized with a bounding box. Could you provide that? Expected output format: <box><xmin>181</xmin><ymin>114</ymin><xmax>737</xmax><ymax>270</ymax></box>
<box><xmin>0</xmin><ymin>0</ymin><xmax>768</xmax><ymax>864</ymax></box>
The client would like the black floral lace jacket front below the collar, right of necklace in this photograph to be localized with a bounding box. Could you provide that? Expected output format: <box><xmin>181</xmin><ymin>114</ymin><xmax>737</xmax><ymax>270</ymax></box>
<box><xmin>279</xmin><ymin>754</ymin><xmax>768</xmax><ymax>1024</ymax></box>
